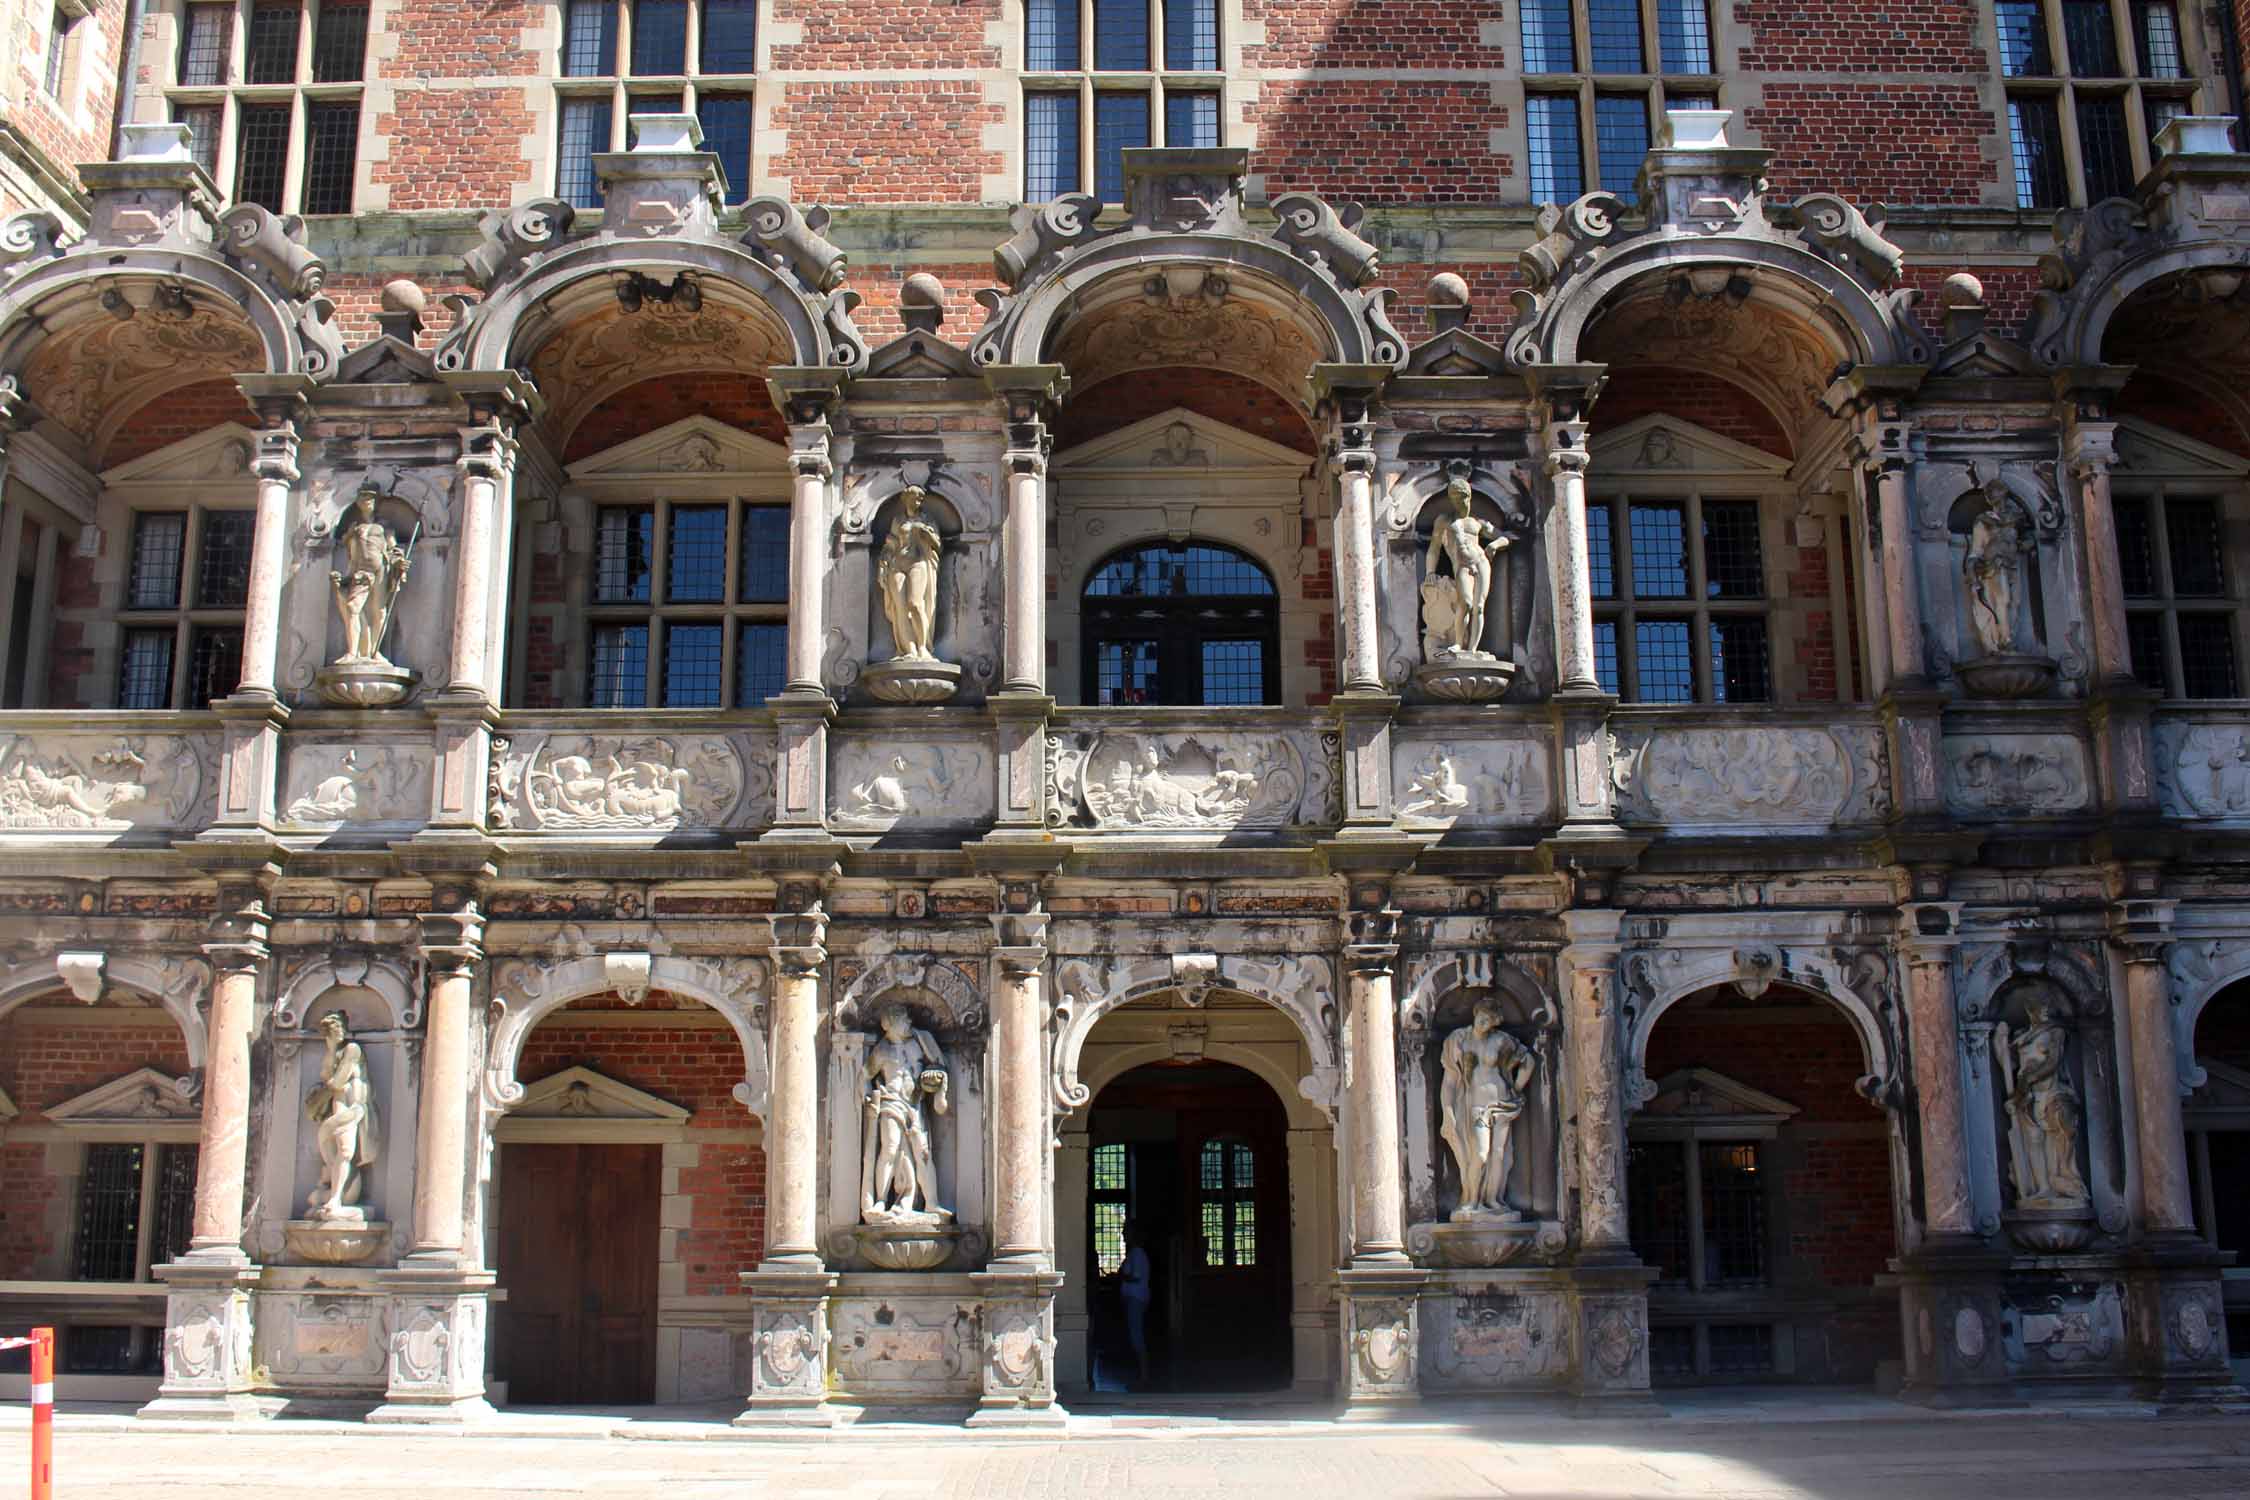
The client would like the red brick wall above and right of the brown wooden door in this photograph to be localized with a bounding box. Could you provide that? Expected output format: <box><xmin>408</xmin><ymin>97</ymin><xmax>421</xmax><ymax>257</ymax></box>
<box><xmin>515</xmin><ymin>996</ymin><xmax>765</xmax><ymax>1298</ymax></box>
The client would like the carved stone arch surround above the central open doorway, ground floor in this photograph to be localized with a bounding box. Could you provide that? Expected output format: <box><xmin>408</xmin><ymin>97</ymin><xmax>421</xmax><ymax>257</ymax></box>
<box><xmin>1049</xmin><ymin>954</ymin><xmax>1343</xmax><ymax>1122</ymax></box>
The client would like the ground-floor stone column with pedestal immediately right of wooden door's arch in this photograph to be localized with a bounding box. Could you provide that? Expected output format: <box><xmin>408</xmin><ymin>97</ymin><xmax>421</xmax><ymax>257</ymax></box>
<box><xmin>734</xmin><ymin>902</ymin><xmax>837</xmax><ymax>1428</ymax></box>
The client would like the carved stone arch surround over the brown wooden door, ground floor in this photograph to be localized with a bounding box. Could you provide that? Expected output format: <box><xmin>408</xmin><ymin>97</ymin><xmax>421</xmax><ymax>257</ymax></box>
<box><xmin>484</xmin><ymin>954</ymin><xmax>772</xmax><ymax>1120</ymax></box>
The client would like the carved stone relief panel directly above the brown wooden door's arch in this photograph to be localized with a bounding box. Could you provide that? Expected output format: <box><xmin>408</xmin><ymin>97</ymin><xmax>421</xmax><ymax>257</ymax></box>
<box><xmin>495</xmin><ymin>733</ymin><xmax>772</xmax><ymax>832</ymax></box>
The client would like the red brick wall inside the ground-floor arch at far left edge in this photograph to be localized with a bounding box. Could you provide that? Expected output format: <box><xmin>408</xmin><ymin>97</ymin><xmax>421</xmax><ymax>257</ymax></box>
<box><xmin>0</xmin><ymin>996</ymin><xmax>187</xmax><ymax>1280</ymax></box>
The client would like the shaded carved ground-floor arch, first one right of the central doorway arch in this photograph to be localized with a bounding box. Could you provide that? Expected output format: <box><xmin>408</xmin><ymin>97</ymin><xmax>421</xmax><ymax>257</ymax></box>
<box><xmin>1618</xmin><ymin>942</ymin><xmax>1899</xmax><ymax>1111</ymax></box>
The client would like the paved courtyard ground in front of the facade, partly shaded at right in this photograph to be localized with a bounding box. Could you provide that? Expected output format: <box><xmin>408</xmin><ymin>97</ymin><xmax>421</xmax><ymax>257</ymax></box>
<box><xmin>0</xmin><ymin>1397</ymin><xmax>2250</xmax><ymax>1500</ymax></box>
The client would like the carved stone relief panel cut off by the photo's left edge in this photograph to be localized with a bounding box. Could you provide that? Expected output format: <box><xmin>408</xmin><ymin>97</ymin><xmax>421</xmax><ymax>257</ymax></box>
<box><xmin>0</xmin><ymin>735</ymin><xmax>216</xmax><ymax>832</ymax></box>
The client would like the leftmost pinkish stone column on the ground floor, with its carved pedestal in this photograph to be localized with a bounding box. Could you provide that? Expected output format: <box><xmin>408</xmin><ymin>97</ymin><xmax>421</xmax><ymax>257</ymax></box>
<box><xmin>142</xmin><ymin>888</ymin><xmax>268</xmax><ymax>1421</ymax></box>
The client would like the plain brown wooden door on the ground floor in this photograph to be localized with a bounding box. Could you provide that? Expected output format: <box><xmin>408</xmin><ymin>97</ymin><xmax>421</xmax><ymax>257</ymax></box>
<box><xmin>495</xmin><ymin>1145</ymin><xmax>664</xmax><ymax>1406</ymax></box>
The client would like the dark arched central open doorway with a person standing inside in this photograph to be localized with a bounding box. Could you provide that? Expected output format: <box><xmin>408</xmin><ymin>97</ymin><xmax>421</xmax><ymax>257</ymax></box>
<box><xmin>1085</xmin><ymin>1061</ymin><xmax>1289</xmax><ymax>1394</ymax></box>
